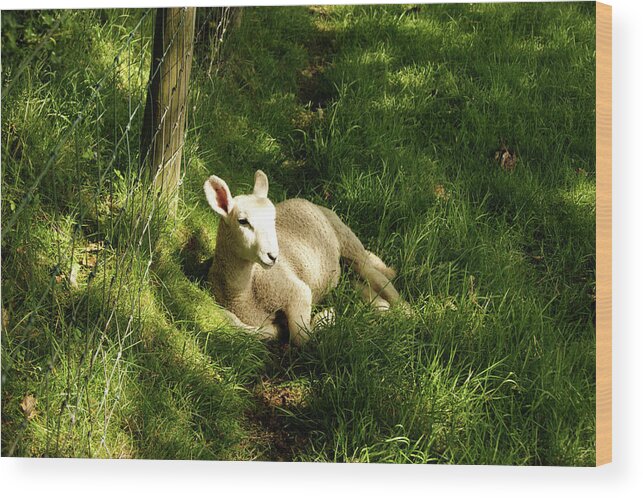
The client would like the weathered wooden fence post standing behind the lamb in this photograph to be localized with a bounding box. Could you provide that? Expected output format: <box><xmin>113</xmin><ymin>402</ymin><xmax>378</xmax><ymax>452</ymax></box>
<box><xmin>141</xmin><ymin>7</ymin><xmax>196</xmax><ymax>214</ymax></box>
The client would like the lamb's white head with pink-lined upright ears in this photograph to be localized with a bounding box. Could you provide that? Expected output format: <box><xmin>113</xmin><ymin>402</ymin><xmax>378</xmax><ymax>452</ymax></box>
<box><xmin>203</xmin><ymin>170</ymin><xmax>279</xmax><ymax>269</ymax></box>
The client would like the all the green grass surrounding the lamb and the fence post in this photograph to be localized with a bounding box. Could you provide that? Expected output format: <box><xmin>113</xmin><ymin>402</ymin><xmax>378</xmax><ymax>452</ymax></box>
<box><xmin>2</xmin><ymin>3</ymin><xmax>596</xmax><ymax>465</ymax></box>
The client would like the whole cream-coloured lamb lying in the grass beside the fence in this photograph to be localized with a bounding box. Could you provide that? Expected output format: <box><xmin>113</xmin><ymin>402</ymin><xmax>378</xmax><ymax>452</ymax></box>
<box><xmin>204</xmin><ymin>170</ymin><xmax>406</xmax><ymax>346</ymax></box>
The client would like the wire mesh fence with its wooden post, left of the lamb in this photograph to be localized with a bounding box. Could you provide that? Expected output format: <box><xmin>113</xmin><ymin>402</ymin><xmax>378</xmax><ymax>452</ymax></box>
<box><xmin>1</xmin><ymin>7</ymin><xmax>240</xmax><ymax>457</ymax></box>
